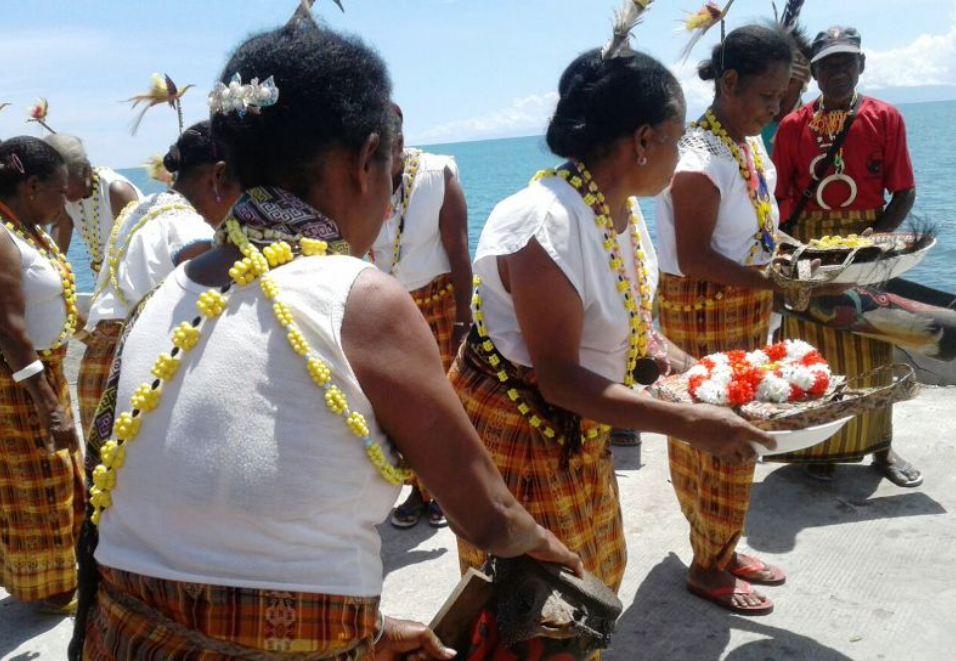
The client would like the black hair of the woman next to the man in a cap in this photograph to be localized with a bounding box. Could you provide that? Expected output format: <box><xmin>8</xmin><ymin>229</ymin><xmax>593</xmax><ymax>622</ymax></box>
<box><xmin>697</xmin><ymin>23</ymin><xmax>793</xmax><ymax>93</ymax></box>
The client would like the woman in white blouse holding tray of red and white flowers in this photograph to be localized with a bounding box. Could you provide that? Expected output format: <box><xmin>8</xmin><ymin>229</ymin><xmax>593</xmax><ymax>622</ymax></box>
<box><xmin>449</xmin><ymin>29</ymin><xmax>769</xmax><ymax>644</ymax></box>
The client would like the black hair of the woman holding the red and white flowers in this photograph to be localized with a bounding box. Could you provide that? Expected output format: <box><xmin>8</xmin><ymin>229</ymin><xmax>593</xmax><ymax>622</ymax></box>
<box><xmin>546</xmin><ymin>48</ymin><xmax>684</xmax><ymax>160</ymax></box>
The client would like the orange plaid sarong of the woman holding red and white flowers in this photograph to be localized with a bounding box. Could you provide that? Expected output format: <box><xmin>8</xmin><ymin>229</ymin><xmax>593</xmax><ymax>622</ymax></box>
<box><xmin>448</xmin><ymin>341</ymin><xmax>627</xmax><ymax>591</ymax></box>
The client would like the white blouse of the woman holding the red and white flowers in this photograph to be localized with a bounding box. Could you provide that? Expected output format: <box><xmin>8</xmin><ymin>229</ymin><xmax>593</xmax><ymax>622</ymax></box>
<box><xmin>475</xmin><ymin>177</ymin><xmax>658</xmax><ymax>383</ymax></box>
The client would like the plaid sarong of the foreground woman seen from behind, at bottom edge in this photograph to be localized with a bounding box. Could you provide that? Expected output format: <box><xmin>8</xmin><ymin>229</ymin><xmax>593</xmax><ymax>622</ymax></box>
<box><xmin>83</xmin><ymin>567</ymin><xmax>379</xmax><ymax>661</ymax></box>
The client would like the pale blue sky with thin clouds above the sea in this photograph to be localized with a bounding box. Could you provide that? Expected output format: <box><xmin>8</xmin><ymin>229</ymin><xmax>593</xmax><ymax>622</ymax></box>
<box><xmin>0</xmin><ymin>0</ymin><xmax>956</xmax><ymax>167</ymax></box>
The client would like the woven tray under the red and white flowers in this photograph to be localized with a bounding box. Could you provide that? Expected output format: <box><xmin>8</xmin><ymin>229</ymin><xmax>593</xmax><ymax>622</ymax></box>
<box><xmin>648</xmin><ymin>365</ymin><xmax>919</xmax><ymax>431</ymax></box>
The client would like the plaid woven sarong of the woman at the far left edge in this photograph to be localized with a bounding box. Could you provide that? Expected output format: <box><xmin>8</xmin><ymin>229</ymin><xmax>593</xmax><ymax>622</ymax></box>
<box><xmin>0</xmin><ymin>346</ymin><xmax>84</xmax><ymax>601</ymax></box>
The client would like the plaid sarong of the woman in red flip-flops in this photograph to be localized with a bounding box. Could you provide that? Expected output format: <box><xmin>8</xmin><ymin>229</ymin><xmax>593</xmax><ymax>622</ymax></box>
<box><xmin>660</xmin><ymin>273</ymin><xmax>773</xmax><ymax>569</ymax></box>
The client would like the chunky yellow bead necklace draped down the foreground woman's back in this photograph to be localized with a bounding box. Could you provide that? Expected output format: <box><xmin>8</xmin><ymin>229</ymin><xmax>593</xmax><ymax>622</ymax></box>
<box><xmin>90</xmin><ymin>218</ymin><xmax>412</xmax><ymax>525</ymax></box>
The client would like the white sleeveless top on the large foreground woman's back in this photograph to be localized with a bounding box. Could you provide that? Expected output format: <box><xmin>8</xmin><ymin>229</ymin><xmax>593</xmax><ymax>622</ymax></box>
<box><xmin>96</xmin><ymin>256</ymin><xmax>401</xmax><ymax>597</ymax></box>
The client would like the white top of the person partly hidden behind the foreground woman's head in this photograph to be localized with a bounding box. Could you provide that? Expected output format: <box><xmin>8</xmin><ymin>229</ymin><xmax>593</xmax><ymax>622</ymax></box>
<box><xmin>372</xmin><ymin>152</ymin><xmax>458</xmax><ymax>291</ymax></box>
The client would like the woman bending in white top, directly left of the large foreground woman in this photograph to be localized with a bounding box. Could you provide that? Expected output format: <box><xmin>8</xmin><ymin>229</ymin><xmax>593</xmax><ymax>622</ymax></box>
<box><xmin>77</xmin><ymin>121</ymin><xmax>239</xmax><ymax>432</ymax></box>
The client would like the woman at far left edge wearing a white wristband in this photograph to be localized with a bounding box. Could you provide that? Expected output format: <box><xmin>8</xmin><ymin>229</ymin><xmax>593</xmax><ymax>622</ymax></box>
<box><xmin>0</xmin><ymin>137</ymin><xmax>84</xmax><ymax>613</ymax></box>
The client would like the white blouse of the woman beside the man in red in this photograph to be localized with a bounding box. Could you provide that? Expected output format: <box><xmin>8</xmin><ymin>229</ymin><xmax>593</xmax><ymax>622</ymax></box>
<box><xmin>654</xmin><ymin>128</ymin><xmax>780</xmax><ymax>276</ymax></box>
